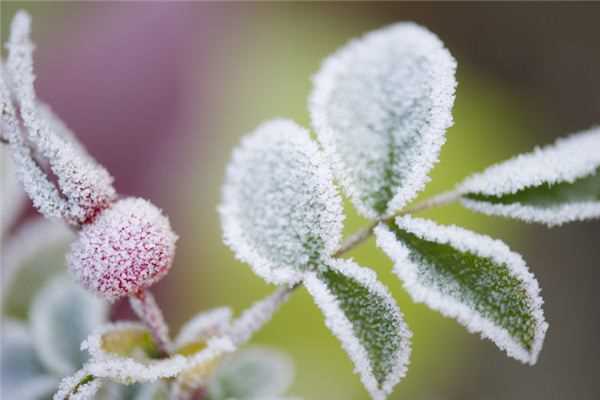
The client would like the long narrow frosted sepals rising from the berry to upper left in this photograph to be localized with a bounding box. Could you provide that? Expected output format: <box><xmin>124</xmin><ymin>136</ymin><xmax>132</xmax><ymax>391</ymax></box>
<box><xmin>2</xmin><ymin>11</ymin><xmax>116</xmax><ymax>225</ymax></box>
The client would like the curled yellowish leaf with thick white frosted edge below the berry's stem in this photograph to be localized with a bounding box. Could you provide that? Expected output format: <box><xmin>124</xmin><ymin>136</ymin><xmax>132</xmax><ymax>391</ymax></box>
<box><xmin>81</xmin><ymin>322</ymin><xmax>234</xmax><ymax>384</ymax></box>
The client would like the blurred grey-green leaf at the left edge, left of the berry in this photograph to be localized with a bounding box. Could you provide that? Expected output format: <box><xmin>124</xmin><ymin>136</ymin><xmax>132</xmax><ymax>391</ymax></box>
<box><xmin>0</xmin><ymin>218</ymin><xmax>74</xmax><ymax>319</ymax></box>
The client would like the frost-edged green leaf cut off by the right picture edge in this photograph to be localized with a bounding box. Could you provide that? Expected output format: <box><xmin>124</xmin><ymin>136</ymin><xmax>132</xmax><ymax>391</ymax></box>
<box><xmin>459</xmin><ymin>128</ymin><xmax>600</xmax><ymax>226</ymax></box>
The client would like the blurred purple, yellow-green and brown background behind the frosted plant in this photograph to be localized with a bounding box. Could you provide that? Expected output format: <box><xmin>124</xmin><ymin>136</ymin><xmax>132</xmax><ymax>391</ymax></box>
<box><xmin>0</xmin><ymin>1</ymin><xmax>600</xmax><ymax>400</ymax></box>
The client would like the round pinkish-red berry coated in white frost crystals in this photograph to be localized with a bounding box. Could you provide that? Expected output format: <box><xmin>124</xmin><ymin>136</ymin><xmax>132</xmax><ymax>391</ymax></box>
<box><xmin>68</xmin><ymin>198</ymin><xmax>177</xmax><ymax>301</ymax></box>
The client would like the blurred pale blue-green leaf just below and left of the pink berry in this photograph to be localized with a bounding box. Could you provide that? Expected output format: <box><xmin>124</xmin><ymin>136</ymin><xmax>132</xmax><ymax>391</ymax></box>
<box><xmin>30</xmin><ymin>274</ymin><xmax>108</xmax><ymax>376</ymax></box>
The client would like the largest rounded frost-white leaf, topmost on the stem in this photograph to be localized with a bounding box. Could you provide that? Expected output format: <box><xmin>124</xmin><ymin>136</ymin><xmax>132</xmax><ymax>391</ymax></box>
<box><xmin>309</xmin><ymin>23</ymin><xmax>456</xmax><ymax>219</ymax></box>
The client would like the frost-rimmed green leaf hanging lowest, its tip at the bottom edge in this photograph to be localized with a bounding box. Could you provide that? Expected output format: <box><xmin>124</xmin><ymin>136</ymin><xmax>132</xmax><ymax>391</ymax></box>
<box><xmin>304</xmin><ymin>260</ymin><xmax>411</xmax><ymax>400</ymax></box>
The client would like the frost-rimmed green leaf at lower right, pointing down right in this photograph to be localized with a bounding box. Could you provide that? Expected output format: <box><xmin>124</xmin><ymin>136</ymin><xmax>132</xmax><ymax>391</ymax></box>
<box><xmin>375</xmin><ymin>216</ymin><xmax>548</xmax><ymax>364</ymax></box>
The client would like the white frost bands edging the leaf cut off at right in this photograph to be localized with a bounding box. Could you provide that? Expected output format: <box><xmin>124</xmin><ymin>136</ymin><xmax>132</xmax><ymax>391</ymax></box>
<box><xmin>458</xmin><ymin>128</ymin><xmax>600</xmax><ymax>226</ymax></box>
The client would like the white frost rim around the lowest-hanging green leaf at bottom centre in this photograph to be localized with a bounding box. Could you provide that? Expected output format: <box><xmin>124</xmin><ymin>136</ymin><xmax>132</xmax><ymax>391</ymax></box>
<box><xmin>304</xmin><ymin>259</ymin><xmax>412</xmax><ymax>400</ymax></box>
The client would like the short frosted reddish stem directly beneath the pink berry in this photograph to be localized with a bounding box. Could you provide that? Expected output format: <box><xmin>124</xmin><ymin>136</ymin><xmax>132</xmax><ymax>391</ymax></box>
<box><xmin>129</xmin><ymin>290</ymin><xmax>171</xmax><ymax>356</ymax></box>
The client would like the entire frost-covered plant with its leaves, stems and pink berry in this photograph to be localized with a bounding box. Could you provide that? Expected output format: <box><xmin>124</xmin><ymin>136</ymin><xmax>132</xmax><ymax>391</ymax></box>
<box><xmin>0</xmin><ymin>8</ymin><xmax>600</xmax><ymax>400</ymax></box>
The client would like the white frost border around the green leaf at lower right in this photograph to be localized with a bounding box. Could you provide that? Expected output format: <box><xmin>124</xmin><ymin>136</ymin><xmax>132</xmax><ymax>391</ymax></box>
<box><xmin>375</xmin><ymin>216</ymin><xmax>548</xmax><ymax>365</ymax></box>
